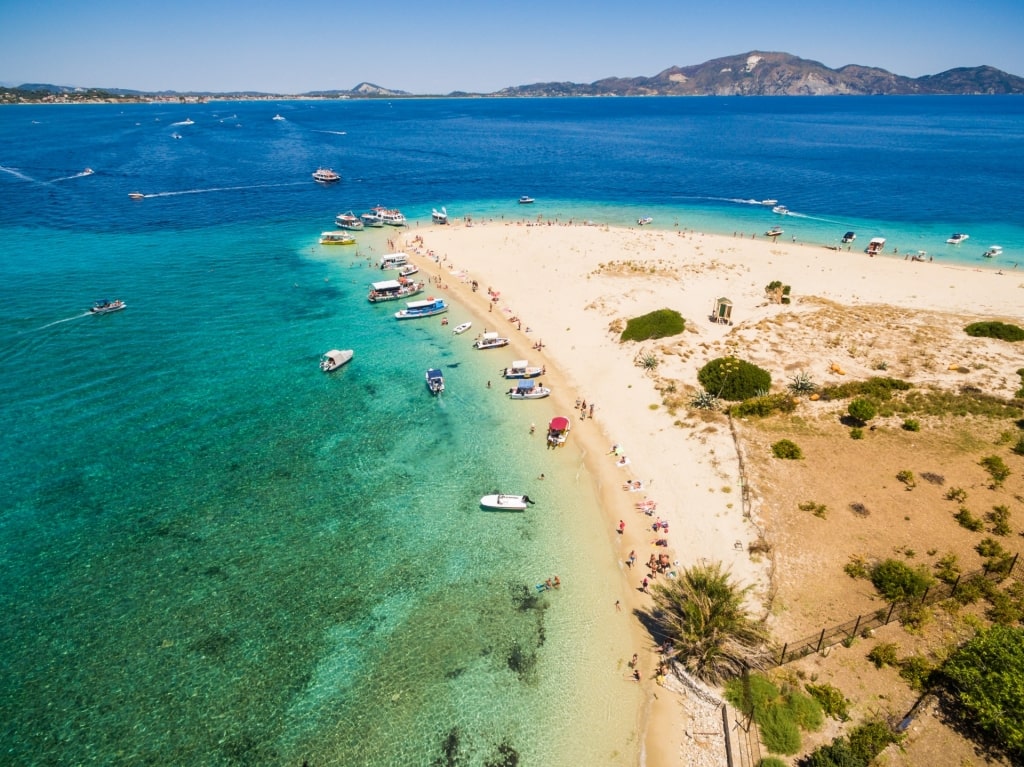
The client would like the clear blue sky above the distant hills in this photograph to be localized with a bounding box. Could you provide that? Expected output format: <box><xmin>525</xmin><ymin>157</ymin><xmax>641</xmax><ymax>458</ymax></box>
<box><xmin>0</xmin><ymin>0</ymin><xmax>1024</xmax><ymax>93</ymax></box>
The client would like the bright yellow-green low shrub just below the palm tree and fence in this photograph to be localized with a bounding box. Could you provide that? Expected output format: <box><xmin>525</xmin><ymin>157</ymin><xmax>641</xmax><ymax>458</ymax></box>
<box><xmin>725</xmin><ymin>674</ymin><xmax>824</xmax><ymax>754</ymax></box>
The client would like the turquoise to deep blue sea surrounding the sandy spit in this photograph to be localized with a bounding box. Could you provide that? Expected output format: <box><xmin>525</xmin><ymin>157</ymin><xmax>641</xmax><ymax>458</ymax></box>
<box><xmin>0</xmin><ymin>97</ymin><xmax>1024</xmax><ymax>767</ymax></box>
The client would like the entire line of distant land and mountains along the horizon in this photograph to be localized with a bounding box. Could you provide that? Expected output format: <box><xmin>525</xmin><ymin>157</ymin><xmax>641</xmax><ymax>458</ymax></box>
<box><xmin>0</xmin><ymin>51</ymin><xmax>1024</xmax><ymax>103</ymax></box>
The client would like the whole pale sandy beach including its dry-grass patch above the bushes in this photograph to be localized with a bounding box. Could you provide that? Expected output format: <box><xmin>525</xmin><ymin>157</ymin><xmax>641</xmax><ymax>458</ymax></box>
<box><xmin>394</xmin><ymin>220</ymin><xmax>1024</xmax><ymax>767</ymax></box>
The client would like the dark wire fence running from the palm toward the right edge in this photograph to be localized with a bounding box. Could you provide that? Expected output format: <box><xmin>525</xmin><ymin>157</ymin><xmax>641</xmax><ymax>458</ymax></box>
<box><xmin>772</xmin><ymin>555</ymin><xmax>1024</xmax><ymax>666</ymax></box>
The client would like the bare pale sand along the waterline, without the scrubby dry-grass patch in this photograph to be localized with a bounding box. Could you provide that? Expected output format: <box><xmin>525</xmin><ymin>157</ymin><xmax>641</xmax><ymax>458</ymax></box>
<box><xmin>393</xmin><ymin>221</ymin><xmax>1024</xmax><ymax>767</ymax></box>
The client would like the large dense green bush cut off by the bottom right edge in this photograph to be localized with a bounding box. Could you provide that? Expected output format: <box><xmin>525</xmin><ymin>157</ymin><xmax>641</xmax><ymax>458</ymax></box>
<box><xmin>936</xmin><ymin>626</ymin><xmax>1024</xmax><ymax>761</ymax></box>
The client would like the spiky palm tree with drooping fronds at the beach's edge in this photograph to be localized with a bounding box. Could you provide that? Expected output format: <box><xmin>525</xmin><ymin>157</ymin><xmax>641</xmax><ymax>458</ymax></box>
<box><xmin>651</xmin><ymin>562</ymin><xmax>770</xmax><ymax>684</ymax></box>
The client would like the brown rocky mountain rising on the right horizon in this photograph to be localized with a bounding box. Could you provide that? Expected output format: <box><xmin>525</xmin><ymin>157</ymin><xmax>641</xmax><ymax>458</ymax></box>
<box><xmin>494</xmin><ymin>51</ymin><xmax>1024</xmax><ymax>96</ymax></box>
